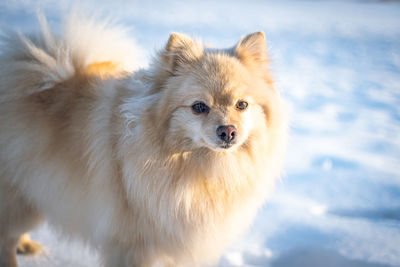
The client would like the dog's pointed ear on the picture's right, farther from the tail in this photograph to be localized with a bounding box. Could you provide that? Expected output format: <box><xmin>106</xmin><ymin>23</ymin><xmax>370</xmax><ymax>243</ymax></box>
<box><xmin>235</xmin><ymin>32</ymin><xmax>268</xmax><ymax>65</ymax></box>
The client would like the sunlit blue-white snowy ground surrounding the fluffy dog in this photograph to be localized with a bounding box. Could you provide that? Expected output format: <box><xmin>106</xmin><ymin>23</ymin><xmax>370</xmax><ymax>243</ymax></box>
<box><xmin>0</xmin><ymin>0</ymin><xmax>400</xmax><ymax>267</ymax></box>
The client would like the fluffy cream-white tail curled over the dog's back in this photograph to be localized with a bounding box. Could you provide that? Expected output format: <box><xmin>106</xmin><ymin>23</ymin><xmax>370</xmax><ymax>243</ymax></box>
<box><xmin>0</xmin><ymin>14</ymin><xmax>144</xmax><ymax>102</ymax></box>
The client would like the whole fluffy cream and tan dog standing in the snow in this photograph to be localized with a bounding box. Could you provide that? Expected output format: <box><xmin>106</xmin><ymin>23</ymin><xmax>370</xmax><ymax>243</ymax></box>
<box><xmin>0</xmin><ymin>16</ymin><xmax>287</xmax><ymax>267</ymax></box>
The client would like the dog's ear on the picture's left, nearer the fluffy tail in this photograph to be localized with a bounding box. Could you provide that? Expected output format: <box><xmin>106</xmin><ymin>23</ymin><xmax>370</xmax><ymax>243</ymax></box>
<box><xmin>164</xmin><ymin>33</ymin><xmax>204</xmax><ymax>73</ymax></box>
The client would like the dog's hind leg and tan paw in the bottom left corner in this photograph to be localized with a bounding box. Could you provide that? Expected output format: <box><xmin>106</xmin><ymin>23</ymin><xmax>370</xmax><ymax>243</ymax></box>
<box><xmin>0</xmin><ymin>184</ymin><xmax>42</xmax><ymax>267</ymax></box>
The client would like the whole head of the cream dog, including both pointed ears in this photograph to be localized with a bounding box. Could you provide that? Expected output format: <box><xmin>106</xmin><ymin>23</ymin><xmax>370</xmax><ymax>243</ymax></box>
<box><xmin>155</xmin><ymin>33</ymin><xmax>276</xmax><ymax>151</ymax></box>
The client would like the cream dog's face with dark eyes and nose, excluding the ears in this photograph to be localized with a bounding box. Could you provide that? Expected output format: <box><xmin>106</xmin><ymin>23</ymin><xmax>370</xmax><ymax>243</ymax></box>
<box><xmin>166</xmin><ymin>57</ymin><xmax>260</xmax><ymax>151</ymax></box>
